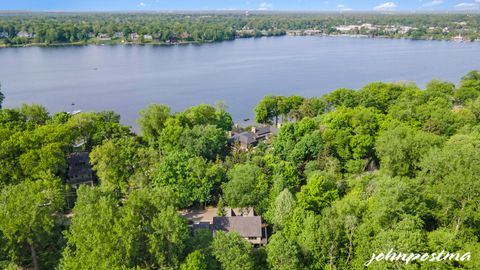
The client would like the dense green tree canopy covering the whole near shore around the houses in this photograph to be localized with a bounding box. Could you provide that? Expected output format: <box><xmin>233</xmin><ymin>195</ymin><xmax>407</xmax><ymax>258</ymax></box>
<box><xmin>0</xmin><ymin>71</ymin><xmax>480</xmax><ymax>270</ymax></box>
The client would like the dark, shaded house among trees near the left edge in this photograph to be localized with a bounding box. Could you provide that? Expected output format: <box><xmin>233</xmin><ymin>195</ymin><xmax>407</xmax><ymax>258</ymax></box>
<box><xmin>67</xmin><ymin>152</ymin><xmax>97</xmax><ymax>189</ymax></box>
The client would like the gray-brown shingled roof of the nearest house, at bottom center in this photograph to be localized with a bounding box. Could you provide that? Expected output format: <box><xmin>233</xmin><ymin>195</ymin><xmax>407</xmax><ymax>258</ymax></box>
<box><xmin>213</xmin><ymin>216</ymin><xmax>262</xmax><ymax>238</ymax></box>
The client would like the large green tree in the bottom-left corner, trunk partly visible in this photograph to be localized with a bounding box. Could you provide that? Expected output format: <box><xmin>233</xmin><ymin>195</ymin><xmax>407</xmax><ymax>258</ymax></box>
<box><xmin>0</xmin><ymin>175</ymin><xmax>64</xmax><ymax>269</ymax></box>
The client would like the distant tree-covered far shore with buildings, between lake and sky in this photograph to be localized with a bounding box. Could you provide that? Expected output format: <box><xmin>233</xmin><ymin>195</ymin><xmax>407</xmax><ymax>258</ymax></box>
<box><xmin>0</xmin><ymin>12</ymin><xmax>480</xmax><ymax>46</ymax></box>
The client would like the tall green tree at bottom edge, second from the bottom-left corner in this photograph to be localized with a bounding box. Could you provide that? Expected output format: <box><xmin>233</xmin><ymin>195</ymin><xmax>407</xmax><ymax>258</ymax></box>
<box><xmin>60</xmin><ymin>186</ymin><xmax>124</xmax><ymax>269</ymax></box>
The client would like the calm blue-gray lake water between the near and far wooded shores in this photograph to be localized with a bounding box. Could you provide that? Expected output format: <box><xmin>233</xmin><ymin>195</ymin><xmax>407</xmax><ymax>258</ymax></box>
<box><xmin>0</xmin><ymin>37</ymin><xmax>480</xmax><ymax>125</ymax></box>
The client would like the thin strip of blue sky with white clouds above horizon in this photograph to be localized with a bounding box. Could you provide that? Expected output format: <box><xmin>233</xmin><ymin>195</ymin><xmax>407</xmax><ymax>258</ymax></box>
<box><xmin>0</xmin><ymin>0</ymin><xmax>480</xmax><ymax>11</ymax></box>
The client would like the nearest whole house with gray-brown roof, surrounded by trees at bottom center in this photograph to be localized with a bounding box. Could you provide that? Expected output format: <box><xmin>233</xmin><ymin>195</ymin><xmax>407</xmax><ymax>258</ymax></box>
<box><xmin>211</xmin><ymin>208</ymin><xmax>268</xmax><ymax>247</ymax></box>
